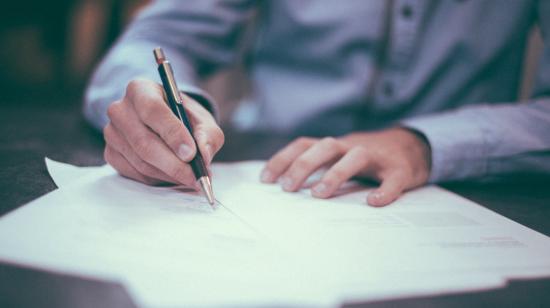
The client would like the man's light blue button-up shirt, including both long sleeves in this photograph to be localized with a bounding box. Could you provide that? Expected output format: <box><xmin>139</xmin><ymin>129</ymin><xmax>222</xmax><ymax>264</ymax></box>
<box><xmin>84</xmin><ymin>0</ymin><xmax>550</xmax><ymax>182</ymax></box>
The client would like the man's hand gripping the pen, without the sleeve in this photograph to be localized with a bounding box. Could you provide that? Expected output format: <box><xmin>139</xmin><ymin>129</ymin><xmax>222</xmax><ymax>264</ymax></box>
<box><xmin>103</xmin><ymin>80</ymin><xmax>224</xmax><ymax>187</ymax></box>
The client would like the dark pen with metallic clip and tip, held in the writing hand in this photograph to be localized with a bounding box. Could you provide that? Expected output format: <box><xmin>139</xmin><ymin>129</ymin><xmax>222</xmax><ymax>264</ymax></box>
<box><xmin>153</xmin><ymin>47</ymin><xmax>218</xmax><ymax>208</ymax></box>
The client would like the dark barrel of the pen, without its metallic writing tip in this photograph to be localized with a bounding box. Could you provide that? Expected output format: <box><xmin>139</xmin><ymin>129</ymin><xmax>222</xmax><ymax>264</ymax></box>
<box><xmin>158</xmin><ymin>61</ymin><xmax>208</xmax><ymax>180</ymax></box>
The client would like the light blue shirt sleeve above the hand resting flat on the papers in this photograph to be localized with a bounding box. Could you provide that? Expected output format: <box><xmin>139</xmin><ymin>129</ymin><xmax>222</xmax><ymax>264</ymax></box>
<box><xmin>402</xmin><ymin>1</ymin><xmax>550</xmax><ymax>182</ymax></box>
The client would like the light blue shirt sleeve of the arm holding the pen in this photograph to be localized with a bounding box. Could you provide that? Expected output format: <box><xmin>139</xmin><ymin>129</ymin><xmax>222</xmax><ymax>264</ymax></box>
<box><xmin>83</xmin><ymin>0</ymin><xmax>255</xmax><ymax>129</ymax></box>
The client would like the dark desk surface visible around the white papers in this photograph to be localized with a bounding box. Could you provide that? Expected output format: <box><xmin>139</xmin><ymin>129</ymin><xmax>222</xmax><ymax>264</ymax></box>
<box><xmin>0</xmin><ymin>105</ymin><xmax>550</xmax><ymax>307</ymax></box>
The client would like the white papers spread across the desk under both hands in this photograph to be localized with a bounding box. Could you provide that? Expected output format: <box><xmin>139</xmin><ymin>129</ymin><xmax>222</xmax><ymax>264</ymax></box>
<box><xmin>0</xmin><ymin>160</ymin><xmax>550</xmax><ymax>307</ymax></box>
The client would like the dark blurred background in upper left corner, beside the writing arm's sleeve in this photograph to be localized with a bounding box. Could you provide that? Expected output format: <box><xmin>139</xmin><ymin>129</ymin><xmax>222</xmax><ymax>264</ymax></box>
<box><xmin>0</xmin><ymin>0</ymin><xmax>148</xmax><ymax>105</ymax></box>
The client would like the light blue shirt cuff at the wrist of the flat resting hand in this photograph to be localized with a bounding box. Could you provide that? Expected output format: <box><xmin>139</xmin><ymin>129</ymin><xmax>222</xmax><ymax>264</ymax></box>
<box><xmin>401</xmin><ymin>112</ymin><xmax>488</xmax><ymax>183</ymax></box>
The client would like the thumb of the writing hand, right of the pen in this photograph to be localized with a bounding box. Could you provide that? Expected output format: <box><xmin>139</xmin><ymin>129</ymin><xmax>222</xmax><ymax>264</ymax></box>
<box><xmin>181</xmin><ymin>94</ymin><xmax>225</xmax><ymax>164</ymax></box>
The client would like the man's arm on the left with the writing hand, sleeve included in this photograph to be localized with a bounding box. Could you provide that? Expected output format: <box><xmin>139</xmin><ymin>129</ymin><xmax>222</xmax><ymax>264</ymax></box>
<box><xmin>84</xmin><ymin>0</ymin><xmax>253</xmax><ymax>187</ymax></box>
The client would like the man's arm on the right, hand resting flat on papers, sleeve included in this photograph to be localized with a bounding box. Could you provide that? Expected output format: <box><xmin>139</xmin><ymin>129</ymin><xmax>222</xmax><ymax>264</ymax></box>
<box><xmin>262</xmin><ymin>1</ymin><xmax>550</xmax><ymax>206</ymax></box>
